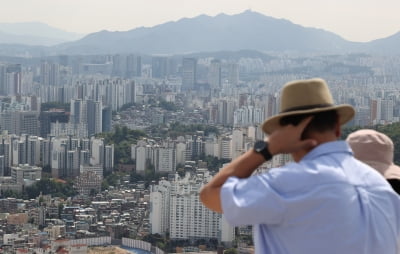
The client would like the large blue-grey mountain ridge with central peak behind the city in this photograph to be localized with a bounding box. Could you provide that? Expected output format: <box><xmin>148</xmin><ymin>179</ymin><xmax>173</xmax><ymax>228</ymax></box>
<box><xmin>0</xmin><ymin>11</ymin><xmax>400</xmax><ymax>55</ymax></box>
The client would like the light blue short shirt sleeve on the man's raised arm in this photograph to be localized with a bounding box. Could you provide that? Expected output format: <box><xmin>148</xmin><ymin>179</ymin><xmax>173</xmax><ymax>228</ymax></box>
<box><xmin>220</xmin><ymin>175</ymin><xmax>286</xmax><ymax>226</ymax></box>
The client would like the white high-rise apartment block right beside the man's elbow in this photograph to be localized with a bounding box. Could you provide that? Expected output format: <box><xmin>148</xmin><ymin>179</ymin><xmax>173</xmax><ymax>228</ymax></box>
<box><xmin>150</xmin><ymin>169</ymin><xmax>234</xmax><ymax>242</ymax></box>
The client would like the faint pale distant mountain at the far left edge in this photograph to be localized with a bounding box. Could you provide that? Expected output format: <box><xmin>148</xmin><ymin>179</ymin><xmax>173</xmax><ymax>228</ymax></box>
<box><xmin>0</xmin><ymin>22</ymin><xmax>83</xmax><ymax>46</ymax></box>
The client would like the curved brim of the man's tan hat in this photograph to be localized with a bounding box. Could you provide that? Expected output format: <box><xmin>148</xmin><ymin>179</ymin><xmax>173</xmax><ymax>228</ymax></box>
<box><xmin>262</xmin><ymin>104</ymin><xmax>355</xmax><ymax>135</ymax></box>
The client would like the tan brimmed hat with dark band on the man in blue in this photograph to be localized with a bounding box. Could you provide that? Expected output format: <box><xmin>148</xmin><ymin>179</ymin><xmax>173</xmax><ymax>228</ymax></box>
<box><xmin>262</xmin><ymin>78</ymin><xmax>355</xmax><ymax>134</ymax></box>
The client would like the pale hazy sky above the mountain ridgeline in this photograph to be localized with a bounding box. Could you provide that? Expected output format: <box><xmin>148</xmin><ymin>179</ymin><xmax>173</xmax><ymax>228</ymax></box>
<box><xmin>0</xmin><ymin>0</ymin><xmax>400</xmax><ymax>41</ymax></box>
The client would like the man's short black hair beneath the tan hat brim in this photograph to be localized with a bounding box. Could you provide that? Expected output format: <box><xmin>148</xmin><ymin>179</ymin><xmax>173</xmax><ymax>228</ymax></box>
<box><xmin>279</xmin><ymin>110</ymin><xmax>339</xmax><ymax>139</ymax></box>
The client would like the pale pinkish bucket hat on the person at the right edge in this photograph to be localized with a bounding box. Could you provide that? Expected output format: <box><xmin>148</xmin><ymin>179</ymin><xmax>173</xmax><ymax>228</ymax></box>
<box><xmin>346</xmin><ymin>129</ymin><xmax>400</xmax><ymax>179</ymax></box>
